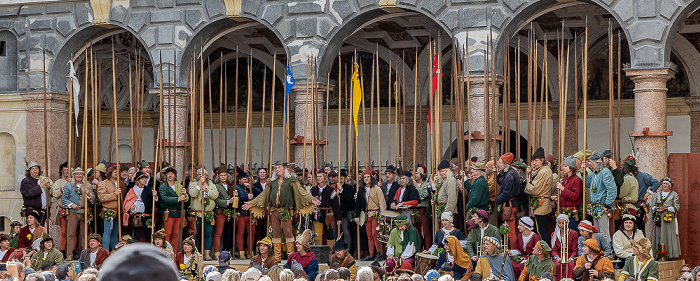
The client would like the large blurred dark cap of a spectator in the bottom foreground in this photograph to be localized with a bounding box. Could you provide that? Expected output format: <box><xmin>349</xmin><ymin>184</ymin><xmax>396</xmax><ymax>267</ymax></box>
<box><xmin>100</xmin><ymin>243</ymin><xmax>179</xmax><ymax>281</ymax></box>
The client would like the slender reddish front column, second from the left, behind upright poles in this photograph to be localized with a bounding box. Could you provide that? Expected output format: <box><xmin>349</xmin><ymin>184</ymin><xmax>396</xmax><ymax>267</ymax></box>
<box><xmin>158</xmin><ymin>88</ymin><xmax>189</xmax><ymax>177</ymax></box>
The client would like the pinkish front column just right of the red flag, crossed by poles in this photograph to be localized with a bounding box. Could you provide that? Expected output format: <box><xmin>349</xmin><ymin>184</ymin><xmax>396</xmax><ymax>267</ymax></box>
<box><xmin>462</xmin><ymin>75</ymin><xmax>503</xmax><ymax>159</ymax></box>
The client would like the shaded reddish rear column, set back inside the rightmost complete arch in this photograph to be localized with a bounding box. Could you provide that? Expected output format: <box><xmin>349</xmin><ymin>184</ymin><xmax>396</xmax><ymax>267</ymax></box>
<box><xmin>549</xmin><ymin>101</ymin><xmax>580</xmax><ymax>159</ymax></box>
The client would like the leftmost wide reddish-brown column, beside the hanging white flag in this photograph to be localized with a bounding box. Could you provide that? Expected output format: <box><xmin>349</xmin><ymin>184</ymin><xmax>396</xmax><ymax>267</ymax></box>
<box><xmin>22</xmin><ymin>93</ymin><xmax>69</xmax><ymax>180</ymax></box>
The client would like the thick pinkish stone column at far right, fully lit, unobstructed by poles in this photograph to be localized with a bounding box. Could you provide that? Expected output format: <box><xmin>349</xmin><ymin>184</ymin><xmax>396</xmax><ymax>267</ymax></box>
<box><xmin>625</xmin><ymin>68</ymin><xmax>676</xmax><ymax>179</ymax></box>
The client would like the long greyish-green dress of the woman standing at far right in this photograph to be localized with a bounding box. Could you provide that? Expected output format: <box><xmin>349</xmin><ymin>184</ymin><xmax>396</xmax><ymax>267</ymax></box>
<box><xmin>653</xmin><ymin>190</ymin><xmax>681</xmax><ymax>259</ymax></box>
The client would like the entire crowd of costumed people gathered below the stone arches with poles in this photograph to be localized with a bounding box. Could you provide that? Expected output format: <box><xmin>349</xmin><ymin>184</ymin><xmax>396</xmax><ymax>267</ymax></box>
<box><xmin>0</xmin><ymin>145</ymin><xmax>684</xmax><ymax>281</ymax></box>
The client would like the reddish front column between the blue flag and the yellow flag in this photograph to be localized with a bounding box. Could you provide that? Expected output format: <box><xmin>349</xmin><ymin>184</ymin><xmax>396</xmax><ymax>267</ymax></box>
<box><xmin>291</xmin><ymin>82</ymin><xmax>330</xmax><ymax>171</ymax></box>
